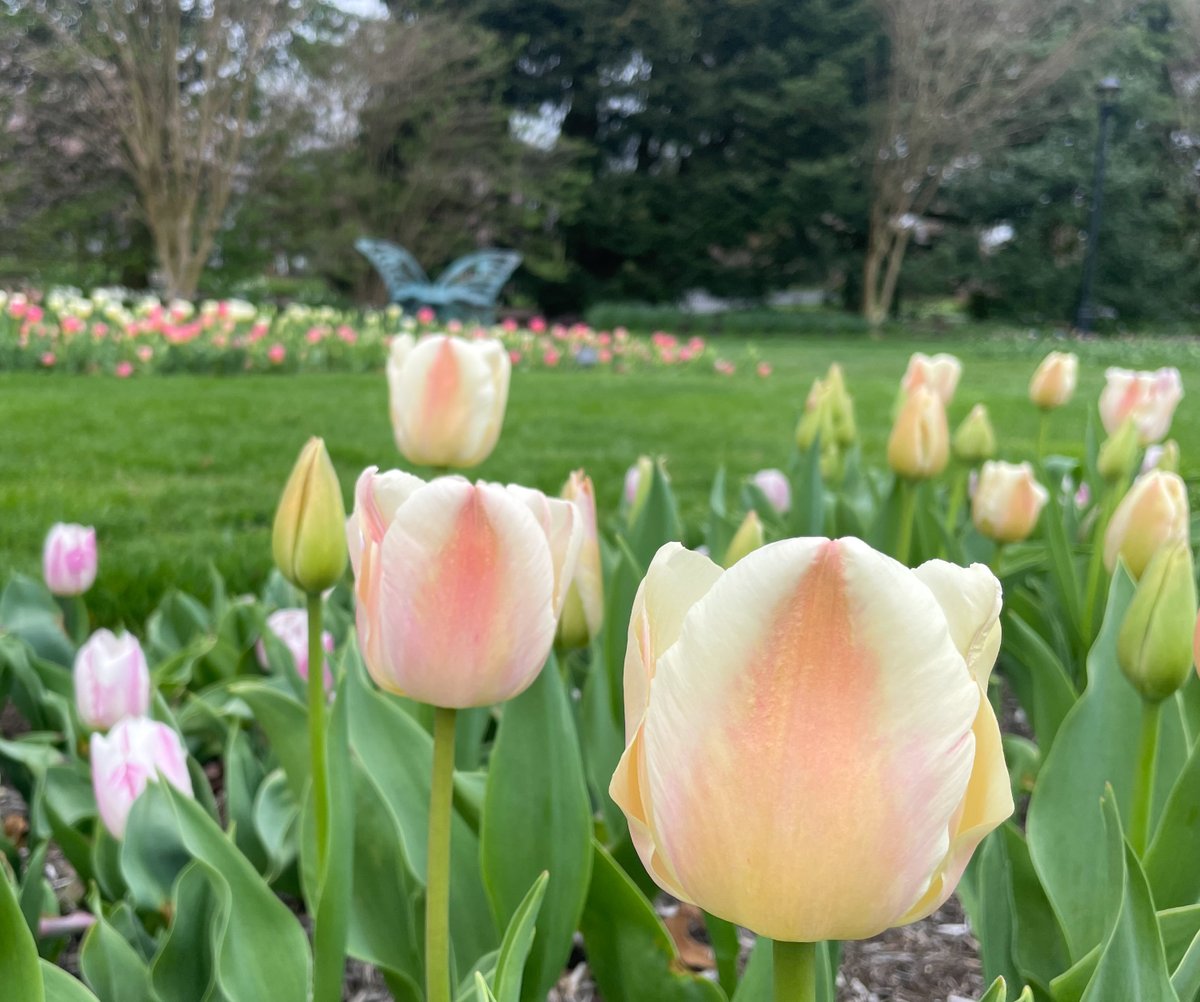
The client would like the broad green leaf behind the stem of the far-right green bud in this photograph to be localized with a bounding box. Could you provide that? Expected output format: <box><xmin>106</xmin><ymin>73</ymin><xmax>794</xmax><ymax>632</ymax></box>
<box><xmin>1027</xmin><ymin>570</ymin><xmax>1184</xmax><ymax>961</ymax></box>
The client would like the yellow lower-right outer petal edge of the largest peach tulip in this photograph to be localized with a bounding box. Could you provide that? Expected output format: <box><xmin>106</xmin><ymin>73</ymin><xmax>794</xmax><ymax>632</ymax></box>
<box><xmin>894</xmin><ymin>686</ymin><xmax>1013</xmax><ymax>925</ymax></box>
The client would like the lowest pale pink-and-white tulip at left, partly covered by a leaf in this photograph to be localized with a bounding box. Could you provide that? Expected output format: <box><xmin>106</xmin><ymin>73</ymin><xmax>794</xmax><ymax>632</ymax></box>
<box><xmin>91</xmin><ymin>716</ymin><xmax>192</xmax><ymax>839</ymax></box>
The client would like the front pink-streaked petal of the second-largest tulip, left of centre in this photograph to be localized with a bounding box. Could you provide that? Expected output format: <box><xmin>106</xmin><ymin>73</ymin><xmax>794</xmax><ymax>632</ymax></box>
<box><xmin>374</xmin><ymin>476</ymin><xmax>554</xmax><ymax>708</ymax></box>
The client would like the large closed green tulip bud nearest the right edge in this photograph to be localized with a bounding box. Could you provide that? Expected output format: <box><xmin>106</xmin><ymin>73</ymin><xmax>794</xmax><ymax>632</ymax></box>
<box><xmin>1117</xmin><ymin>542</ymin><xmax>1196</xmax><ymax>703</ymax></box>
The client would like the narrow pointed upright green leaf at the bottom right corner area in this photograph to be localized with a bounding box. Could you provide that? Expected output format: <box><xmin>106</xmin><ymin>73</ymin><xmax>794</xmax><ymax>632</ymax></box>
<box><xmin>1082</xmin><ymin>796</ymin><xmax>1178</xmax><ymax>1002</ymax></box>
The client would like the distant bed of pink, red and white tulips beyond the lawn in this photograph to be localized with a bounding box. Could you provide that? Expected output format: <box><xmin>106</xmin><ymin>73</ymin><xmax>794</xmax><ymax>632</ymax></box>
<box><xmin>0</xmin><ymin>289</ymin><xmax>744</xmax><ymax>379</ymax></box>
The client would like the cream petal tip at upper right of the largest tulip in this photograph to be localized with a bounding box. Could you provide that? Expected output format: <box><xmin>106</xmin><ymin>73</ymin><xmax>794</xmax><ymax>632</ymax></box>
<box><xmin>913</xmin><ymin>560</ymin><xmax>1003</xmax><ymax>688</ymax></box>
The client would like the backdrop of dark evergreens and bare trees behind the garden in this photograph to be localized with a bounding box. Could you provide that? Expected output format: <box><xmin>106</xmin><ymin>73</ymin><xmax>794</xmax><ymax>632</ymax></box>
<box><xmin>0</xmin><ymin>0</ymin><xmax>1200</xmax><ymax>322</ymax></box>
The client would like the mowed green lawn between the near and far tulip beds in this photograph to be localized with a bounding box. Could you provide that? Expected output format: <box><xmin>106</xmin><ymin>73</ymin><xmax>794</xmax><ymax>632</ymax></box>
<box><xmin>0</xmin><ymin>336</ymin><xmax>1200</xmax><ymax>625</ymax></box>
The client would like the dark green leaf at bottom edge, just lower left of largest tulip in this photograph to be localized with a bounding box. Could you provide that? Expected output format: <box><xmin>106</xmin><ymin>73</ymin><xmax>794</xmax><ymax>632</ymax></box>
<box><xmin>582</xmin><ymin>844</ymin><xmax>725</xmax><ymax>1002</ymax></box>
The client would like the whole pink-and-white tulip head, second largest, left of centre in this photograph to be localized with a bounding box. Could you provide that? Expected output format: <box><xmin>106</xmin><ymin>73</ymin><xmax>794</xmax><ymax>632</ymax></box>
<box><xmin>347</xmin><ymin>467</ymin><xmax>583</xmax><ymax>709</ymax></box>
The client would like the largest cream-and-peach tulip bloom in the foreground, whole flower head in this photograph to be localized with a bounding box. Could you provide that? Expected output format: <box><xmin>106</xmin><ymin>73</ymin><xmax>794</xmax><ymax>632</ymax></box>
<box><xmin>610</xmin><ymin>539</ymin><xmax>1013</xmax><ymax>942</ymax></box>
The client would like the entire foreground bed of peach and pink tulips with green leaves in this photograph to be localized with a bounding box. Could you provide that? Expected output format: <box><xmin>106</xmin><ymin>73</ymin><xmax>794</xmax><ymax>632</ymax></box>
<box><xmin>0</xmin><ymin>334</ymin><xmax>1200</xmax><ymax>1002</ymax></box>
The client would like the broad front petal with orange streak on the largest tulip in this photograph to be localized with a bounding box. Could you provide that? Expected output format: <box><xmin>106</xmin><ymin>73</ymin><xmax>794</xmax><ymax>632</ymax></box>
<box><xmin>643</xmin><ymin>539</ymin><xmax>979</xmax><ymax>942</ymax></box>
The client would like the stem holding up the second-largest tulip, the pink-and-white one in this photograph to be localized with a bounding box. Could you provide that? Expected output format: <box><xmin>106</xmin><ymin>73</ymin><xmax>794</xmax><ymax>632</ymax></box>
<box><xmin>425</xmin><ymin>707</ymin><xmax>456</xmax><ymax>1002</ymax></box>
